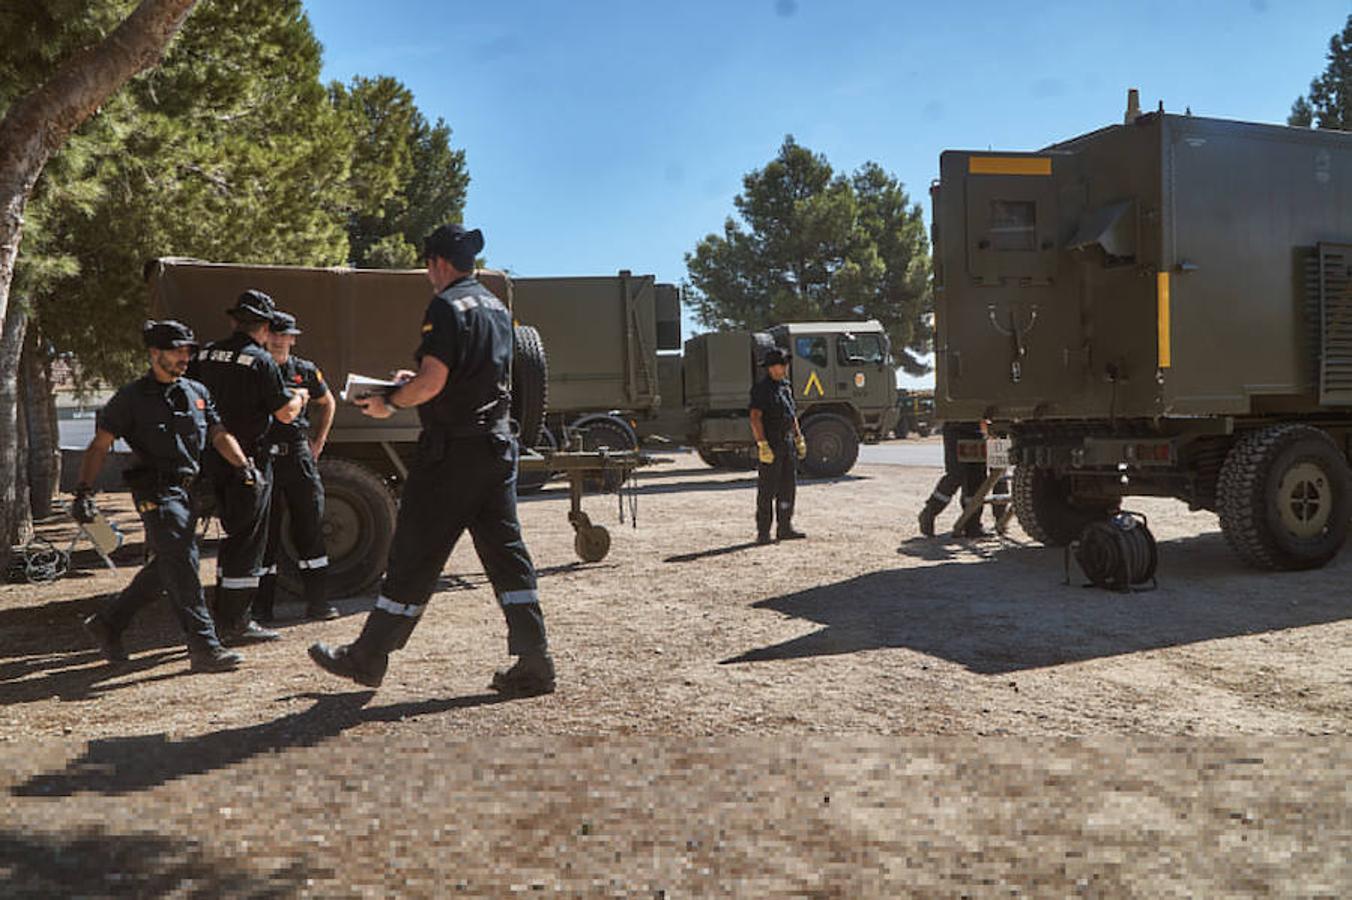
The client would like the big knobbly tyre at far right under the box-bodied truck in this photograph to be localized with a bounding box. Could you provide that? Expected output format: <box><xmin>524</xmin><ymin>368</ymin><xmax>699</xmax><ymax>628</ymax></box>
<box><xmin>1215</xmin><ymin>424</ymin><xmax>1352</xmax><ymax>570</ymax></box>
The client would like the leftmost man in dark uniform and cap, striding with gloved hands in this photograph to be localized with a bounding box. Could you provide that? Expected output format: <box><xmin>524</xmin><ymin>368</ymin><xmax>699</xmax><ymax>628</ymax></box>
<box><xmin>70</xmin><ymin>320</ymin><xmax>258</xmax><ymax>672</ymax></box>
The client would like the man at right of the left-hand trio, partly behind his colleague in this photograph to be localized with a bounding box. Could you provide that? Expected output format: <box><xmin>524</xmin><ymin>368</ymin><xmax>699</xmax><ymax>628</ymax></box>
<box><xmin>254</xmin><ymin>309</ymin><xmax>338</xmax><ymax>623</ymax></box>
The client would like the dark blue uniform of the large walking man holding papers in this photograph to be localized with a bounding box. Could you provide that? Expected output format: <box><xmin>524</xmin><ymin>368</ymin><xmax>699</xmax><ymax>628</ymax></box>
<box><xmin>356</xmin><ymin>276</ymin><xmax>548</xmax><ymax>657</ymax></box>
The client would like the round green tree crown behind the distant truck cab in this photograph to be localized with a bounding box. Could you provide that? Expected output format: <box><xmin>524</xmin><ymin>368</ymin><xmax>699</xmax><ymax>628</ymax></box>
<box><xmin>685</xmin><ymin>136</ymin><xmax>933</xmax><ymax>373</ymax></box>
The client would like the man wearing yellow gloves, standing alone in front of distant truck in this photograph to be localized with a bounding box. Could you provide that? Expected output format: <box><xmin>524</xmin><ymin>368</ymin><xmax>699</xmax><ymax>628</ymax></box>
<box><xmin>750</xmin><ymin>341</ymin><xmax>807</xmax><ymax>543</ymax></box>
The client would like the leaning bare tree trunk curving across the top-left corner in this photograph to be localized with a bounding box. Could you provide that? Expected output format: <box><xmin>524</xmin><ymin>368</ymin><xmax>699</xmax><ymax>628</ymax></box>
<box><xmin>0</xmin><ymin>0</ymin><xmax>197</xmax><ymax>565</ymax></box>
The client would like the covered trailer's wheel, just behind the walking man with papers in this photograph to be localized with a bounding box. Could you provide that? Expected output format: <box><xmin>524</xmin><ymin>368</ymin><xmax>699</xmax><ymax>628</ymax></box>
<box><xmin>319</xmin><ymin>457</ymin><xmax>396</xmax><ymax>597</ymax></box>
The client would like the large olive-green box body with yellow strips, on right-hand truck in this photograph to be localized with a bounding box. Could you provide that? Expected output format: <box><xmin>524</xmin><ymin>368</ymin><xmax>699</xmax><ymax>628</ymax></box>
<box><xmin>934</xmin><ymin>114</ymin><xmax>1352</xmax><ymax>420</ymax></box>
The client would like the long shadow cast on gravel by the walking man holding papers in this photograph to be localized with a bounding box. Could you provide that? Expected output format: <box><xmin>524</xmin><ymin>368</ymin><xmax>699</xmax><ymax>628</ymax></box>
<box><xmin>11</xmin><ymin>691</ymin><xmax>512</xmax><ymax>797</ymax></box>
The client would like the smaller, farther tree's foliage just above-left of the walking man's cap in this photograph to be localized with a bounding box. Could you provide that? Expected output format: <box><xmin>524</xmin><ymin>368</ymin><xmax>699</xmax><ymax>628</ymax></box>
<box><xmin>330</xmin><ymin>76</ymin><xmax>469</xmax><ymax>269</ymax></box>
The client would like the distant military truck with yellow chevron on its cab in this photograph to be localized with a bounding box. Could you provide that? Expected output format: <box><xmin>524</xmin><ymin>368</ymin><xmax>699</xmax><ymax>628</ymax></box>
<box><xmin>683</xmin><ymin>320</ymin><xmax>896</xmax><ymax>478</ymax></box>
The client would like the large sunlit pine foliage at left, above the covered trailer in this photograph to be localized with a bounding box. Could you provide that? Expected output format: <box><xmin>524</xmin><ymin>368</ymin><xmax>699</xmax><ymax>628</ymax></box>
<box><xmin>19</xmin><ymin>0</ymin><xmax>353</xmax><ymax>381</ymax></box>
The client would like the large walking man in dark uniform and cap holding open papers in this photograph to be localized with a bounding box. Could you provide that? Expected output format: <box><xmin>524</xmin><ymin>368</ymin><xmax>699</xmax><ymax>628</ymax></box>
<box><xmin>310</xmin><ymin>224</ymin><xmax>554</xmax><ymax>695</ymax></box>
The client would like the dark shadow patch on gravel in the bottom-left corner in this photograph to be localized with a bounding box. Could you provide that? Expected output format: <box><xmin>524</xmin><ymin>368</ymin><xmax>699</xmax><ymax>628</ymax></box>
<box><xmin>0</xmin><ymin>828</ymin><xmax>319</xmax><ymax>900</ymax></box>
